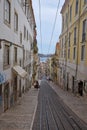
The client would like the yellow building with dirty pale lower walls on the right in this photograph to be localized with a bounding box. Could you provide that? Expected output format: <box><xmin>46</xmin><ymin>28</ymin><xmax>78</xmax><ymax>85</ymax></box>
<box><xmin>59</xmin><ymin>0</ymin><xmax>87</xmax><ymax>92</ymax></box>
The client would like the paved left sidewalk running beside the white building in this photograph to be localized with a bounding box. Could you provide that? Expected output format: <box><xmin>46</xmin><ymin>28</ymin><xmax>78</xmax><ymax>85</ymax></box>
<box><xmin>0</xmin><ymin>88</ymin><xmax>39</xmax><ymax>130</ymax></box>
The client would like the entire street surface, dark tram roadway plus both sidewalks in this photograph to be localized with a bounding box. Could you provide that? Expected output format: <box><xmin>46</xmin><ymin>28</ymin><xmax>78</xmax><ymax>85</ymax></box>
<box><xmin>0</xmin><ymin>80</ymin><xmax>87</xmax><ymax>130</ymax></box>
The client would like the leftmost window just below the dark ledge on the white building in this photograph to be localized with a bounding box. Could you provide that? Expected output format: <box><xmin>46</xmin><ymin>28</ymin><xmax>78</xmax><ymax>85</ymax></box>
<box><xmin>4</xmin><ymin>45</ymin><xmax>10</xmax><ymax>66</ymax></box>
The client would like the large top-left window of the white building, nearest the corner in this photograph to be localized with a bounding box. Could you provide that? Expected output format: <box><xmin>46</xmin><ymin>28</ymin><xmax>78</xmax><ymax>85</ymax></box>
<box><xmin>5</xmin><ymin>0</ymin><xmax>11</xmax><ymax>24</ymax></box>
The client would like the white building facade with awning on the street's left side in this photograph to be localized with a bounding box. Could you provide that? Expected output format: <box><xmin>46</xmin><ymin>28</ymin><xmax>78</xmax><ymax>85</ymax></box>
<box><xmin>0</xmin><ymin>0</ymin><xmax>36</xmax><ymax>113</ymax></box>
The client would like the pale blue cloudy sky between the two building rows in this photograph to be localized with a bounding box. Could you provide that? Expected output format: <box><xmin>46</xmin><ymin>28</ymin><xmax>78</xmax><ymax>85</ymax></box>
<box><xmin>32</xmin><ymin>0</ymin><xmax>65</xmax><ymax>54</ymax></box>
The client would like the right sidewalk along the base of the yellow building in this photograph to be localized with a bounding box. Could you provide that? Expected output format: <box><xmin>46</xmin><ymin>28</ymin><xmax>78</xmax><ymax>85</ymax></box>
<box><xmin>50</xmin><ymin>82</ymin><xmax>87</xmax><ymax>123</ymax></box>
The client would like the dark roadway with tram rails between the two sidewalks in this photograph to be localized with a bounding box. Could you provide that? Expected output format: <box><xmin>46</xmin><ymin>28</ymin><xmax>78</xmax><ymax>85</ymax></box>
<box><xmin>33</xmin><ymin>80</ymin><xmax>87</xmax><ymax>130</ymax></box>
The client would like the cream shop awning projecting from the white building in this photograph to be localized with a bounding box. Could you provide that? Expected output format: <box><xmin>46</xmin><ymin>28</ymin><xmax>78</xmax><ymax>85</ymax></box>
<box><xmin>13</xmin><ymin>65</ymin><xmax>27</xmax><ymax>78</ymax></box>
